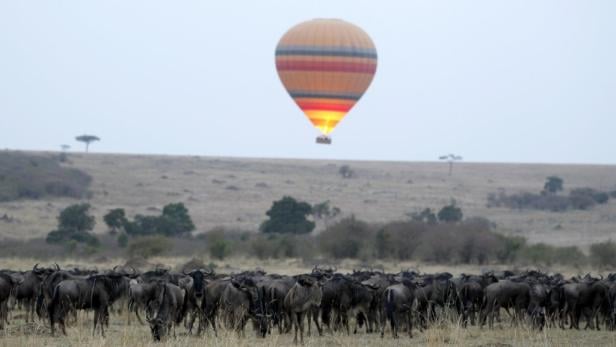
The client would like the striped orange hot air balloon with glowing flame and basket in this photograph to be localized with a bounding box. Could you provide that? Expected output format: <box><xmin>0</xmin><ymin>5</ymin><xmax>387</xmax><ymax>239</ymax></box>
<box><xmin>276</xmin><ymin>19</ymin><xmax>377</xmax><ymax>144</ymax></box>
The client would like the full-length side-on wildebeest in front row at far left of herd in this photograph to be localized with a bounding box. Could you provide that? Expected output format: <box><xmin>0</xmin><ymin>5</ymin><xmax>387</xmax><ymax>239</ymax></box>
<box><xmin>47</xmin><ymin>272</ymin><xmax>133</xmax><ymax>336</ymax></box>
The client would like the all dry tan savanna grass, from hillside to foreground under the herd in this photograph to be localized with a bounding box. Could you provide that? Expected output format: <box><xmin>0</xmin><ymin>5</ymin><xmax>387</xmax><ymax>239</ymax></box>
<box><xmin>0</xmin><ymin>152</ymin><xmax>616</xmax><ymax>347</ymax></box>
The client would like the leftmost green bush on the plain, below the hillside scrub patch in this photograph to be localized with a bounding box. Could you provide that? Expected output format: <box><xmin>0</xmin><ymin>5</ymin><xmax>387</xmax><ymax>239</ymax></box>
<box><xmin>47</xmin><ymin>204</ymin><xmax>99</xmax><ymax>247</ymax></box>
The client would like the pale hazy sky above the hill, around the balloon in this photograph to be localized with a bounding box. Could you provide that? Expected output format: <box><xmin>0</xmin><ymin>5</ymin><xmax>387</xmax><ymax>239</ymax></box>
<box><xmin>0</xmin><ymin>0</ymin><xmax>616</xmax><ymax>163</ymax></box>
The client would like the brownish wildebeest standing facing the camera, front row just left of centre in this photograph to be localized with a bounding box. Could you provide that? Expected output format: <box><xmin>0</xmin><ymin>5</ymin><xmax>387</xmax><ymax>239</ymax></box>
<box><xmin>283</xmin><ymin>274</ymin><xmax>323</xmax><ymax>343</ymax></box>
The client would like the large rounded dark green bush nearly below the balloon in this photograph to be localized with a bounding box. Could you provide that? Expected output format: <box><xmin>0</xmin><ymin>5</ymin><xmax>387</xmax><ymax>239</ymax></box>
<box><xmin>260</xmin><ymin>196</ymin><xmax>315</xmax><ymax>234</ymax></box>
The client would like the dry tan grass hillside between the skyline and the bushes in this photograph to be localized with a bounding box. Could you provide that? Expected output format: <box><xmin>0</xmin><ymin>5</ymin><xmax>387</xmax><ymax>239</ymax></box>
<box><xmin>0</xmin><ymin>153</ymin><xmax>616</xmax><ymax>246</ymax></box>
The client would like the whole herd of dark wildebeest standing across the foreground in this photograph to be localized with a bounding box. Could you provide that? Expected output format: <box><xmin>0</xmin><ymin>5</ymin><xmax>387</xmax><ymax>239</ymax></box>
<box><xmin>0</xmin><ymin>264</ymin><xmax>616</xmax><ymax>342</ymax></box>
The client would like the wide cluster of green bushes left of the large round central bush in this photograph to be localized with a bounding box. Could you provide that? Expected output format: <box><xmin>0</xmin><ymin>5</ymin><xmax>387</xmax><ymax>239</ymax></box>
<box><xmin>124</xmin><ymin>203</ymin><xmax>195</xmax><ymax>237</ymax></box>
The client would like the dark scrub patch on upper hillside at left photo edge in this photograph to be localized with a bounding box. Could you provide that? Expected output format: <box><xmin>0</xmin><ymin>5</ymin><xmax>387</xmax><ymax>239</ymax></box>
<box><xmin>0</xmin><ymin>151</ymin><xmax>92</xmax><ymax>202</ymax></box>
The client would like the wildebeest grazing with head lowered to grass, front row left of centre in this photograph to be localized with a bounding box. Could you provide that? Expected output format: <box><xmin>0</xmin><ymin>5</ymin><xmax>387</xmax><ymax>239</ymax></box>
<box><xmin>148</xmin><ymin>281</ymin><xmax>186</xmax><ymax>341</ymax></box>
